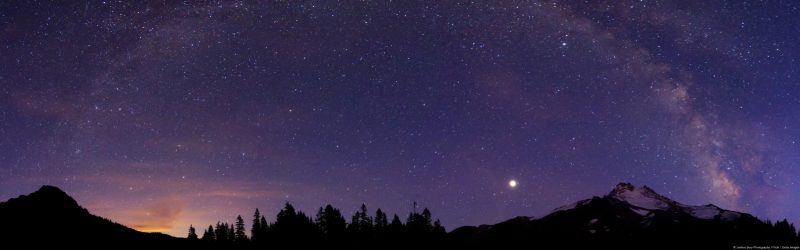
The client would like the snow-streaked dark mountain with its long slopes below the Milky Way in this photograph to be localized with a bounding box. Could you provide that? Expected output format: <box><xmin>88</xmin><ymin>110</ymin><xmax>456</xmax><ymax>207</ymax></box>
<box><xmin>450</xmin><ymin>183</ymin><xmax>799</xmax><ymax>249</ymax></box>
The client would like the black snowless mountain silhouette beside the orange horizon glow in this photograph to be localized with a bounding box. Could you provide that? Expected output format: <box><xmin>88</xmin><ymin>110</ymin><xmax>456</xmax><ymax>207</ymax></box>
<box><xmin>0</xmin><ymin>186</ymin><xmax>180</xmax><ymax>246</ymax></box>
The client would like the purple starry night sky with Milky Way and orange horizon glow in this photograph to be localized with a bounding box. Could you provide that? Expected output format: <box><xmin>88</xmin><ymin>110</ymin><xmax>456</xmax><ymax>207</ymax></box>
<box><xmin>0</xmin><ymin>0</ymin><xmax>800</xmax><ymax>236</ymax></box>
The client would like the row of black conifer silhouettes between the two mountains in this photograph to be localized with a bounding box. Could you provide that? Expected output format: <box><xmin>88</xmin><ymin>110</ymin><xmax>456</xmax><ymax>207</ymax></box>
<box><xmin>188</xmin><ymin>202</ymin><xmax>447</xmax><ymax>247</ymax></box>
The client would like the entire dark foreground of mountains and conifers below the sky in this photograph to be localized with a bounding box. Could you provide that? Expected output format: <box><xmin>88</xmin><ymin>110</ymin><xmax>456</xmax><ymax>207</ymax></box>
<box><xmin>0</xmin><ymin>183</ymin><xmax>800</xmax><ymax>249</ymax></box>
